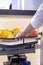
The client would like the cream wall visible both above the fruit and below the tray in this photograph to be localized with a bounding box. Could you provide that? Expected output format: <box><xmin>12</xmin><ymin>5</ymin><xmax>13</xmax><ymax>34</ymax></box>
<box><xmin>0</xmin><ymin>15</ymin><xmax>40</xmax><ymax>65</ymax></box>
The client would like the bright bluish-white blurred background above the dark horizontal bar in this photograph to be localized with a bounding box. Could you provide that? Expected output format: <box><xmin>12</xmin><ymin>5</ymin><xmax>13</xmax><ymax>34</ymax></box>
<box><xmin>0</xmin><ymin>0</ymin><xmax>43</xmax><ymax>10</ymax></box>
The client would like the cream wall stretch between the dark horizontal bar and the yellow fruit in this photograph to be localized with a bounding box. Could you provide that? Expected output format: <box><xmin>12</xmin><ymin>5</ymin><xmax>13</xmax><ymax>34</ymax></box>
<box><xmin>0</xmin><ymin>15</ymin><xmax>32</xmax><ymax>29</ymax></box>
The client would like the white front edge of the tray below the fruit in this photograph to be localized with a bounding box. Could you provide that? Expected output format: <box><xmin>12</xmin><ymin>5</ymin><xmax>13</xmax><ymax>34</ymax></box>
<box><xmin>0</xmin><ymin>38</ymin><xmax>37</xmax><ymax>45</ymax></box>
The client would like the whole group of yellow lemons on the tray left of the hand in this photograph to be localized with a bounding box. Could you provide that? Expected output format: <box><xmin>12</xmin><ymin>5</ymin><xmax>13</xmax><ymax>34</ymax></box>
<box><xmin>0</xmin><ymin>28</ymin><xmax>20</xmax><ymax>38</ymax></box>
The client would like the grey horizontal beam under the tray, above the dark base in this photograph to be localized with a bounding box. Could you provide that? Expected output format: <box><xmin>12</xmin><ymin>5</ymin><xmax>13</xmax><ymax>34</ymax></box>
<box><xmin>0</xmin><ymin>44</ymin><xmax>40</xmax><ymax>55</ymax></box>
